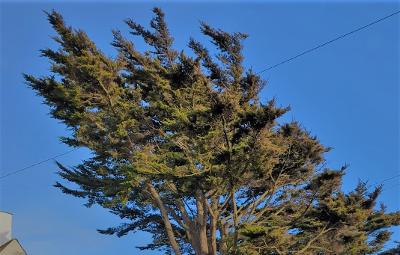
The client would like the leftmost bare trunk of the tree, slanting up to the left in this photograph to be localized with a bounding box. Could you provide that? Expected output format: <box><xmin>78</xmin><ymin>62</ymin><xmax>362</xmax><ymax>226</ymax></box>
<box><xmin>146</xmin><ymin>182</ymin><xmax>182</xmax><ymax>255</ymax></box>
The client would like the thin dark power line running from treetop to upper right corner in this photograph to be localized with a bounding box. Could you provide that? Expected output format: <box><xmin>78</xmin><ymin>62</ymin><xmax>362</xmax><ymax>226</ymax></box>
<box><xmin>257</xmin><ymin>11</ymin><xmax>400</xmax><ymax>74</ymax></box>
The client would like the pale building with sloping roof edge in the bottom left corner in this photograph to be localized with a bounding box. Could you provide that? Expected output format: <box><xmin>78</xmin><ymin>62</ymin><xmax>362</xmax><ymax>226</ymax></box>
<box><xmin>0</xmin><ymin>212</ymin><xmax>26</xmax><ymax>255</ymax></box>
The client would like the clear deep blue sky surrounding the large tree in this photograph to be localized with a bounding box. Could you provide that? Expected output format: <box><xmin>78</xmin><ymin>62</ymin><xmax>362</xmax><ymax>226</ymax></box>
<box><xmin>0</xmin><ymin>2</ymin><xmax>400</xmax><ymax>255</ymax></box>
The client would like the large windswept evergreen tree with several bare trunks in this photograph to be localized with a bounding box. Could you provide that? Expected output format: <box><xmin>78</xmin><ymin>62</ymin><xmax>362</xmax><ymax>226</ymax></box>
<box><xmin>25</xmin><ymin>8</ymin><xmax>400</xmax><ymax>255</ymax></box>
